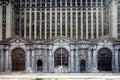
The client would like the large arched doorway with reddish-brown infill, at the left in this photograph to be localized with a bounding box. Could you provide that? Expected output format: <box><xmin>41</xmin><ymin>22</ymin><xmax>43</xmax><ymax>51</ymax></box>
<box><xmin>11</xmin><ymin>48</ymin><xmax>25</xmax><ymax>71</ymax></box>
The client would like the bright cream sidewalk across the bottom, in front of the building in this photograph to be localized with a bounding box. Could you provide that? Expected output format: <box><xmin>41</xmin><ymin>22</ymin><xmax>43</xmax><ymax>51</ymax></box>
<box><xmin>0</xmin><ymin>73</ymin><xmax>120</xmax><ymax>80</ymax></box>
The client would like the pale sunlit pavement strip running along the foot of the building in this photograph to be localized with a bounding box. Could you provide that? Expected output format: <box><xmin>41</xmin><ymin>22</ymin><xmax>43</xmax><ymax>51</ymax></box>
<box><xmin>0</xmin><ymin>72</ymin><xmax>120</xmax><ymax>80</ymax></box>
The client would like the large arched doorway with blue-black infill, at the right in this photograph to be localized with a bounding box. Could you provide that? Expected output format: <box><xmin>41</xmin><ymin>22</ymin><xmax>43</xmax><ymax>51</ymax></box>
<box><xmin>98</xmin><ymin>48</ymin><xmax>112</xmax><ymax>71</ymax></box>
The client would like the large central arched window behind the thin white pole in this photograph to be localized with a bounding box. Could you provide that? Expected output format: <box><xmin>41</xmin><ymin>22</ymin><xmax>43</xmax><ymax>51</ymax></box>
<box><xmin>54</xmin><ymin>48</ymin><xmax>68</xmax><ymax>66</ymax></box>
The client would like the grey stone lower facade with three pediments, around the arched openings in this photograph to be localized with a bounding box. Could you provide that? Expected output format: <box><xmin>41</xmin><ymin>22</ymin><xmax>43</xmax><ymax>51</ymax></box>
<box><xmin>0</xmin><ymin>36</ymin><xmax>120</xmax><ymax>73</ymax></box>
